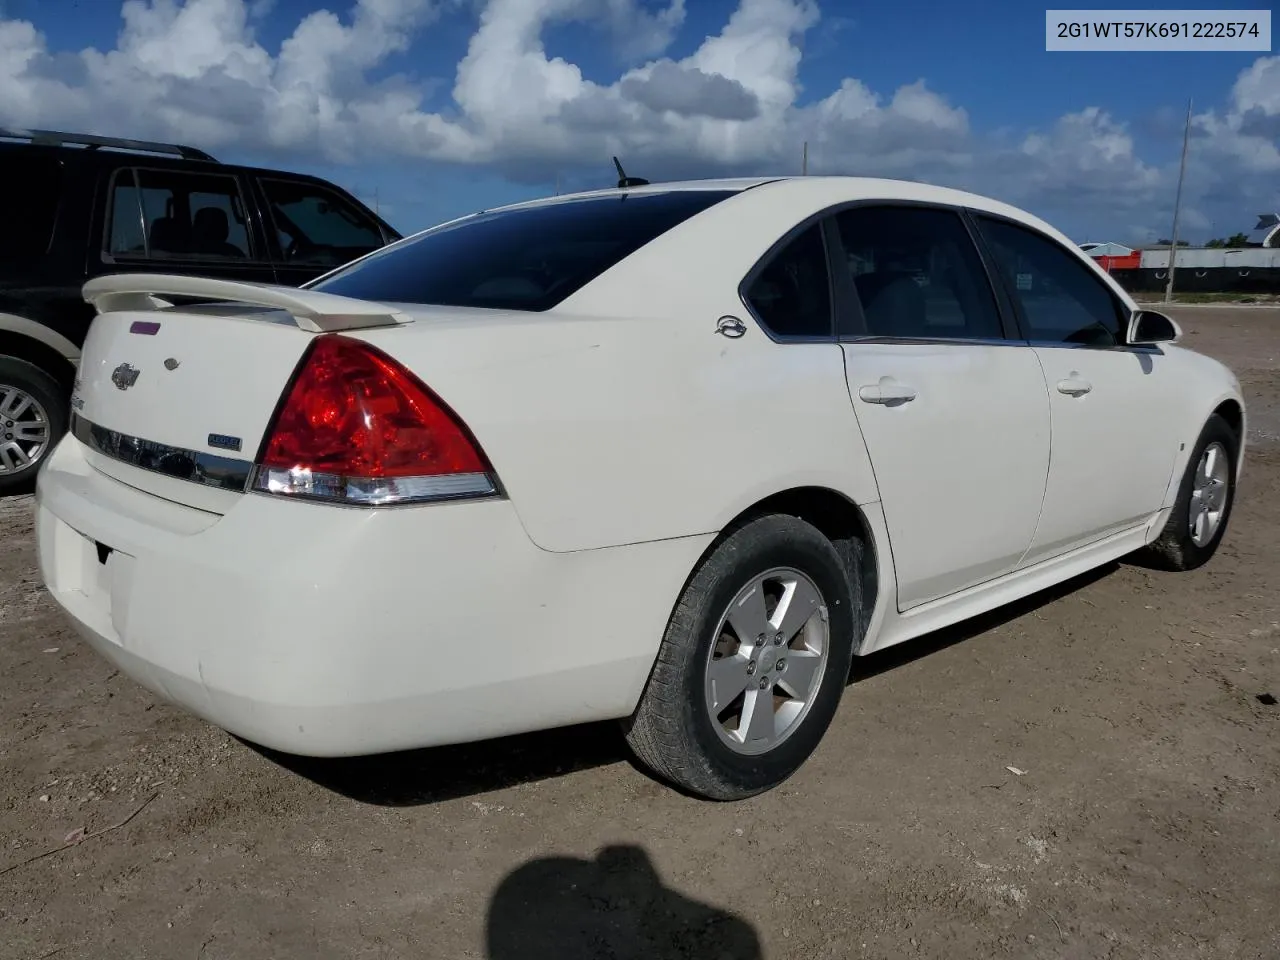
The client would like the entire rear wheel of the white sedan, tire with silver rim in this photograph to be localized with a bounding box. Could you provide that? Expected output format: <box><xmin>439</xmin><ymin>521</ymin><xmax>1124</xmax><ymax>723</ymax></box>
<box><xmin>623</xmin><ymin>515</ymin><xmax>863</xmax><ymax>800</ymax></box>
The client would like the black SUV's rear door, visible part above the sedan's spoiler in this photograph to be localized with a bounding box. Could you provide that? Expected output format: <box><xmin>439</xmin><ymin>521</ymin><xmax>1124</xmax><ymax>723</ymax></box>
<box><xmin>95</xmin><ymin>166</ymin><xmax>275</xmax><ymax>283</ymax></box>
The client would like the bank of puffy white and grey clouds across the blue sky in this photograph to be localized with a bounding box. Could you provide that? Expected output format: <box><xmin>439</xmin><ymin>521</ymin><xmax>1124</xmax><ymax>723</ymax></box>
<box><xmin>0</xmin><ymin>0</ymin><xmax>1280</xmax><ymax>239</ymax></box>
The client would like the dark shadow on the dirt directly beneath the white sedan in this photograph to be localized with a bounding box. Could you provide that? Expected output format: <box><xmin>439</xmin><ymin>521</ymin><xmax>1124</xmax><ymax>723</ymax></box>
<box><xmin>262</xmin><ymin>563</ymin><xmax>1120</xmax><ymax>806</ymax></box>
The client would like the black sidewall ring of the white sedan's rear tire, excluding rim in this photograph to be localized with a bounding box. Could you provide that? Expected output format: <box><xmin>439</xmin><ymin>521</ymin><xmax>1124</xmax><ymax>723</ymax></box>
<box><xmin>681</xmin><ymin>517</ymin><xmax>856</xmax><ymax>795</ymax></box>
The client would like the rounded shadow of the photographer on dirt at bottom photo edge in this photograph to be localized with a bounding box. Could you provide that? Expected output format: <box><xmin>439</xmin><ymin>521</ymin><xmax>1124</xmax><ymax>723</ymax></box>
<box><xmin>485</xmin><ymin>846</ymin><xmax>763</xmax><ymax>960</ymax></box>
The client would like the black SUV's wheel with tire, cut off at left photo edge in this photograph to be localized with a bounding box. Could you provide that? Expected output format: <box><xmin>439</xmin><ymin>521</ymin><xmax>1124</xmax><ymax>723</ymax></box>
<box><xmin>0</xmin><ymin>357</ymin><xmax>69</xmax><ymax>494</ymax></box>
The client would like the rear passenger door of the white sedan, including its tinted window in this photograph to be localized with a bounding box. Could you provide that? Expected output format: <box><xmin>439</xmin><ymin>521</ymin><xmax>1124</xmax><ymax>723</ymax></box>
<box><xmin>833</xmin><ymin>204</ymin><xmax>1050</xmax><ymax>611</ymax></box>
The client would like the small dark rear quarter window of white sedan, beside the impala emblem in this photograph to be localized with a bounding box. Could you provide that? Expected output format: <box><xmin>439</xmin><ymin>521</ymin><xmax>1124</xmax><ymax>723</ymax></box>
<box><xmin>746</xmin><ymin>223</ymin><xmax>833</xmax><ymax>337</ymax></box>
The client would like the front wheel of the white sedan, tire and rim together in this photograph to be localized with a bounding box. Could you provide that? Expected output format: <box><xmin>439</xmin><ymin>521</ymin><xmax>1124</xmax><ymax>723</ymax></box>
<box><xmin>1143</xmin><ymin>413</ymin><xmax>1240</xmax><ymax>571</ymax></box>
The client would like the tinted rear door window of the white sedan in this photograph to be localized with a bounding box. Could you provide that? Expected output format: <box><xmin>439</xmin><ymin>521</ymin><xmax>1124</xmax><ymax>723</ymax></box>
<box><xmin>836</xmin><ymin>206</ymin><xmax>1005</xmax><ymax>339</ymax></box>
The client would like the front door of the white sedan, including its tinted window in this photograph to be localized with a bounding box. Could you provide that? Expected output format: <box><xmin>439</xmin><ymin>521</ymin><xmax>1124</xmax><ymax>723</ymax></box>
<box><xmin>974</xmin><ymin>215</ymin><xmax>1179</xmax><ymax>566</ymax></box>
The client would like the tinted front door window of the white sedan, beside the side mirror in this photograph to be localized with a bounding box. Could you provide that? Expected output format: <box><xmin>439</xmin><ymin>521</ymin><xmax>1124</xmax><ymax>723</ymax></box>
<box><xmin>977</xmin><ymin>216</ymin><xmax>1125</xmax><ymax>347</ymax></box>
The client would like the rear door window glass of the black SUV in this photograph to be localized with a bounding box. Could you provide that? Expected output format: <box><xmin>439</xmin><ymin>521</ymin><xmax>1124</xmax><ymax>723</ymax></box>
<box><xmin>106</xmin><ymin>168</ymin><xmax>253</xmax><ymax>260</ymax></box>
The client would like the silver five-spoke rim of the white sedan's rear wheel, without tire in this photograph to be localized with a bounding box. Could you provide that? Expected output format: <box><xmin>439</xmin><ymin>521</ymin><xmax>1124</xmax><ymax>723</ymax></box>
<box><xmin>705</xmin><ymin>567</ymin><xmax>829</xmax><ymax>755</ymax></box>
